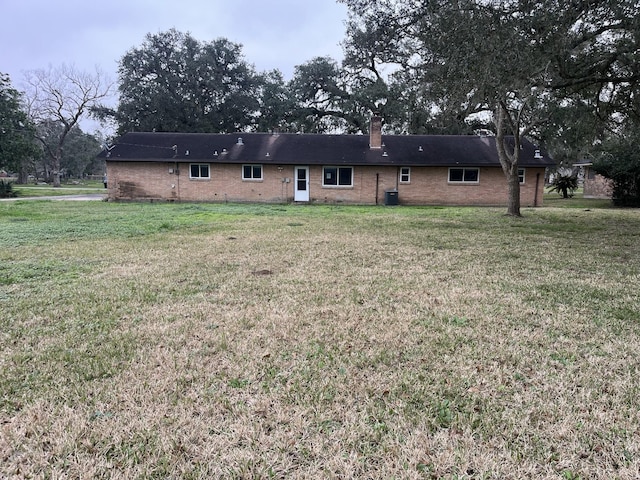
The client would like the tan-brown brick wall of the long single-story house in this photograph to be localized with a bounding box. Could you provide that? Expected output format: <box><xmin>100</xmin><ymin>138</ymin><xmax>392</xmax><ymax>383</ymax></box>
<box><xmin>107</xmin><ymin>160</ymin><xmax>544</xmax><ymax>206</ymax></box>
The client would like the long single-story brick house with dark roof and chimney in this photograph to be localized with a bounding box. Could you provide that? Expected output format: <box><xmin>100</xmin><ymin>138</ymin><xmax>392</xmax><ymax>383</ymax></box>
<box><xmin>101</xmin><ymin>117</ymin><xmax>553</xmax><ymax>206</ymax></box>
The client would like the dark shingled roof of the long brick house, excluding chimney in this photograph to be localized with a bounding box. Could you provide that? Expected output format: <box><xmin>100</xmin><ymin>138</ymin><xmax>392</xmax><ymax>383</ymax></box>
<box><xmin>100</xmin><ymin>132</ymin><xmax>554</xmax><ymax>167</ymax></box>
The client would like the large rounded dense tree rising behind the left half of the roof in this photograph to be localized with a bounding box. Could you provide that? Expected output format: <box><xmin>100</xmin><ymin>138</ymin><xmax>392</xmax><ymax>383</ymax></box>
<box><xmin>116</xmin><ymin>29</ymin><xmax>260</xmax><ymax>133</ymax></box>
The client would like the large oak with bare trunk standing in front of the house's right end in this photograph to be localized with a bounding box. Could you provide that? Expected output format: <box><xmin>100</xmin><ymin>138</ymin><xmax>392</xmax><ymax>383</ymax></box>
<box><xmin>341</xmin><ymin>0</ymin><xmax>640</xmax><ymax>215</ymax></box>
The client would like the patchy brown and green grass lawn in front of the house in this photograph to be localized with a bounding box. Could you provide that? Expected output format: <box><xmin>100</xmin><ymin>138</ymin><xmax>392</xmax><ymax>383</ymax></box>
<box><xmin>0</xmin><ymin>200</ymin><xmax>640</xmax><ymax>480</ymax></box>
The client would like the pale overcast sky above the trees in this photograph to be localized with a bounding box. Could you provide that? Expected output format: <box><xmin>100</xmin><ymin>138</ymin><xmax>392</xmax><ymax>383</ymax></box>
<box><xmin>0</xmin><ymin>0</ymin><xmax>347</xmax><ymax>89</ymax></box>
